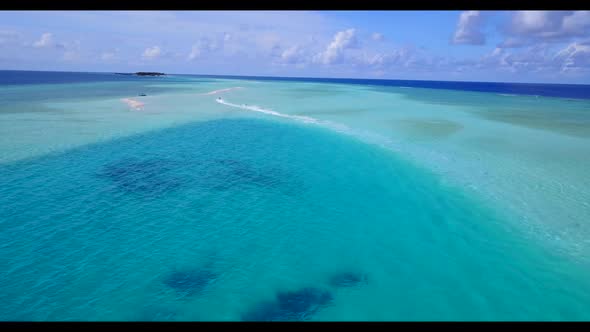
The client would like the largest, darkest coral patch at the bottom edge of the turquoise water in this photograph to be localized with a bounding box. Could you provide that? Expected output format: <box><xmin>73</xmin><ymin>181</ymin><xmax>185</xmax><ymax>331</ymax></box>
<box><xmin>242</xmin><ymin>287</ymin><xmax>333</xmax><ymax>321</ymax></box>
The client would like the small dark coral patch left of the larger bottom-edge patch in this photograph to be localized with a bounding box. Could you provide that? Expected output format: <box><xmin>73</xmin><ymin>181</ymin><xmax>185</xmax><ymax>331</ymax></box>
<box><xmin>164</xmin><ymin>269</ymin><xmax>217</xmax><ymax>296</ymax></box>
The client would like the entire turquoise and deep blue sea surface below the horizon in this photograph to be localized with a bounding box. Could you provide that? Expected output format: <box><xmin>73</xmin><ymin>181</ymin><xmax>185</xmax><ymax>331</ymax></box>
<box><xmin>0</xmin><ymin>71</ymin><xmax>590</xmax><ymax>321</ymax></box>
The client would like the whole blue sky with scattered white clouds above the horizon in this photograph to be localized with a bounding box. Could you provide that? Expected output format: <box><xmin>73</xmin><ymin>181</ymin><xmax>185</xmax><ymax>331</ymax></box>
<box><xmin>0</xmin><ymin>11</ymin><xmax>590</xmax><ymax>84</ymax></box>
